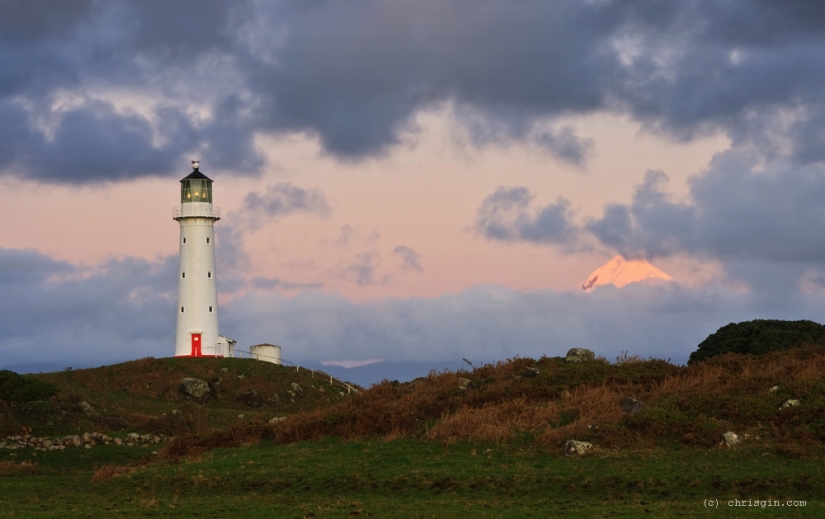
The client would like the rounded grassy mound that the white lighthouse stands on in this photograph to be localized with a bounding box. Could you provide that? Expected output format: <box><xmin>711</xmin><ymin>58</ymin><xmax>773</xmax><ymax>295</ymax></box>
<box><xmin>0</xmin><ymin>358</ymin><xmax>352</xmax><ymax>436</ymax></box>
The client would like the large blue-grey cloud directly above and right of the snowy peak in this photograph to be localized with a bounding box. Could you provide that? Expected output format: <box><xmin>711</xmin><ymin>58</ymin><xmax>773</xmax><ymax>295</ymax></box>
<box><xmin>585</xmin><ymin>151</ymin><xmax>825</xmax><ymax>293</ymax></box>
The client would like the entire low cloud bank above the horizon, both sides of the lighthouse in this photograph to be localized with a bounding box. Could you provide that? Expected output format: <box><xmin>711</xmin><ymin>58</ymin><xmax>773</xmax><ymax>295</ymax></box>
<box><xmin>0</xmin><ymin>245</ymin><xmax>825</xmax><ymax>386</ymax></box>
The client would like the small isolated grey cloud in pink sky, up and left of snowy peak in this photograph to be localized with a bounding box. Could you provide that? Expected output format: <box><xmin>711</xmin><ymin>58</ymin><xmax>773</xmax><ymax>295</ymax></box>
<box><xmin>473</xmin><ymin>186</ymin><xmax>578</xmax><ymax>250</ymax></box>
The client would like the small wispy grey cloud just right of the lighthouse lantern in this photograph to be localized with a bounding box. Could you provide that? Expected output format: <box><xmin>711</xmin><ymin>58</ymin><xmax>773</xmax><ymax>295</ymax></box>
<box><xmin>240</xmin><ymin>182</ymin><xmax>329</xmax><ymax>231</ymax></box>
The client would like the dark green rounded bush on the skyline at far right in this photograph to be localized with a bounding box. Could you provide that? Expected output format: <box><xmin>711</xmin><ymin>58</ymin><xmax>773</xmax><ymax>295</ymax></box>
<box><xmin>688</xmin><ymin>319</ymin><xmax>825</xmax><ymax>364</ymax></box>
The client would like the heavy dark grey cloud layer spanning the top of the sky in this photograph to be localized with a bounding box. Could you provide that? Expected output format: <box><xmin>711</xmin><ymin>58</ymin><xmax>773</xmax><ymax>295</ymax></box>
<box><xmin>8</xmin><ymin>0</ymin><xmax>825</xmax><ymax>183</ymax></box>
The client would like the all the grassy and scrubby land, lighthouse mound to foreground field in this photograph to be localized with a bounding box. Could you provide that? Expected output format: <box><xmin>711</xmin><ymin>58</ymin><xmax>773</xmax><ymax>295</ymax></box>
<box><xmin>0</xmin><ymin>345</ymin><xmax>825</xmax><ymax>517</ymax></box>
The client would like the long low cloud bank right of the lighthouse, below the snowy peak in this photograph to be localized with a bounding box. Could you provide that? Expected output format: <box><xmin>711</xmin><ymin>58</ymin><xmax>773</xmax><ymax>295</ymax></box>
<box><xmin>222</xmin><ymin>284</ymin><xmax>825</xmax><ymax>370</ymax></box>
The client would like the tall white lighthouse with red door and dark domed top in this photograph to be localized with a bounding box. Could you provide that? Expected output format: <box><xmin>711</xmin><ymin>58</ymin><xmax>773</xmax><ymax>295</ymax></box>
<box><xmin>174</xmin><ymin>161</ymin><xmax>224</xmax><ymax>357</ymax></box>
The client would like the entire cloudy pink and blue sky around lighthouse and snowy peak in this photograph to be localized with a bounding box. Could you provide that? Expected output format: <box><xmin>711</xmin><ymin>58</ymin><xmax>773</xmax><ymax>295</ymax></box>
<box><xmin>0</xmin><ymin>0</ymin><xmax>825</xmax><ymax>382</ymax></box>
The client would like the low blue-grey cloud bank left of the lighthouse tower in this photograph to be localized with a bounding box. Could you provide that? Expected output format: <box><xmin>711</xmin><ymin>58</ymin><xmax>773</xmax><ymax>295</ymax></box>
<box><xmin>0</xmin><ymin>249</ymin><xmax>177</xmax><ymax>366</ymax></box>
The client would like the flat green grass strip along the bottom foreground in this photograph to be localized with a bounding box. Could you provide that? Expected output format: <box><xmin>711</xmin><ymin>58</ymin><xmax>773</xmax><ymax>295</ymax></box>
<box><xmin>0</xmin><ymin>439</ymin><xmax>825</xmax><ymax>518</ymax></box>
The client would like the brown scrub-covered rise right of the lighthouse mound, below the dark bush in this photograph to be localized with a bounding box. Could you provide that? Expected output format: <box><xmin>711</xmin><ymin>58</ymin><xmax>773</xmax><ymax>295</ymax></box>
<box><xmin>159</xmin><ymin>346</ymin><xmax>825</xmax><ymax>457</ymax></box>
